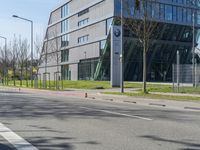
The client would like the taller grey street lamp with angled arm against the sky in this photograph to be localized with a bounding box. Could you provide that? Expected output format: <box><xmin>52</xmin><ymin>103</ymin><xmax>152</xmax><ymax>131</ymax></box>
<box><xmin>12</xmin><ymin>15</ymin><xmax>33</xmax><ymax>87</ymax></box>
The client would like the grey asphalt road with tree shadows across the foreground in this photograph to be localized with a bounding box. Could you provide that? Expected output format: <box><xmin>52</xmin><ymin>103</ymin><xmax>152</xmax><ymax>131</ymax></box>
<box><xmin>0</xmin><ymin>90</ymin><xmax>200</xmax><ymax>150</ymax></box>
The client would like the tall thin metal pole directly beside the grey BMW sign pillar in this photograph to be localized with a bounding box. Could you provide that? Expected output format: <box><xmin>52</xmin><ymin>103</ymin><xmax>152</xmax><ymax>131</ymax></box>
<box><xmin>120</xmin><ymin>0</ymin><xmax>124</xmax><ymax>93</ymax></box>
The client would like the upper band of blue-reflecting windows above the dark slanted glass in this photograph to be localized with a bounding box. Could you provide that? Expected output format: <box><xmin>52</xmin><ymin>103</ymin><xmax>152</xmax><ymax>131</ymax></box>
<box><xmin>115</xmin><ymin>0</ymin><xmax>200</xmax><ymax>25</ymax></box>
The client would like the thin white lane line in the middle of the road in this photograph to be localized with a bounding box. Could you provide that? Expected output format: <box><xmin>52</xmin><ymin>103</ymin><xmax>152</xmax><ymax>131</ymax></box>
<box><xmin>81</xmin><ymin>107</ymin><xmax>153</xmax><ymax>121</ymax></box>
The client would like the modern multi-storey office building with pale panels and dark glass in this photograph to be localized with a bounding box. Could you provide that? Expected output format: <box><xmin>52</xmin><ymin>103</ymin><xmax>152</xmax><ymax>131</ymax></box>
<box><xmin>40</xmin><ymin>0</ymin><xmax>200</xmax><ymax>81</ymax></box>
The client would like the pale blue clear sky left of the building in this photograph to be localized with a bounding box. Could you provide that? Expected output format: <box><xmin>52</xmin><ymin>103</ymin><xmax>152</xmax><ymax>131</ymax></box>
<box><xmin>0</xmin><ymin>0</ymin><xmax>62</xmax><ymax>46</ymax></box>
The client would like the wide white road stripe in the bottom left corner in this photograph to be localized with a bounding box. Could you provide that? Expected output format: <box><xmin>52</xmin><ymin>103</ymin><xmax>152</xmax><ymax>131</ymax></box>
<box><xmin>0</xmin><ymin>123</ymin><xmax>38</xmax><ymax>150</ymax></box>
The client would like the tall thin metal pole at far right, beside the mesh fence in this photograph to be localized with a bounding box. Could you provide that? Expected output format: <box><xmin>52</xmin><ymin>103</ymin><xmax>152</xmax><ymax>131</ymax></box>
<box><xmin>192</xmin><ymin>1</ymin><xmax>195</xmax><ymax>87</ymax></box>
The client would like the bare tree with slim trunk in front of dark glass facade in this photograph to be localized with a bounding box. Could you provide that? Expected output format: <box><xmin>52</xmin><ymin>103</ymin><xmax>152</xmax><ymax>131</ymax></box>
<box><xmin>123</xmin><ymin>0</ymin><xmax>160</xmax><ymax>93</ymax></box>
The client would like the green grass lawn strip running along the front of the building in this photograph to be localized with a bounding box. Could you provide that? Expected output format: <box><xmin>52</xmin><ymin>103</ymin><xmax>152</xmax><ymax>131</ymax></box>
<box><xmin>4</xmin><ymin>80</ymin><xmax>200</xmax><ymax>94</ymax></box>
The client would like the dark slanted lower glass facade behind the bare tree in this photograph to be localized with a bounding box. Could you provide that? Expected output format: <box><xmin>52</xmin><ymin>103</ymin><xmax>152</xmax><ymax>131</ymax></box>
<box><xmin>120</xmin><ymin>23</ymin><xmax>195</xmax><ymax>81</ymax></box>
